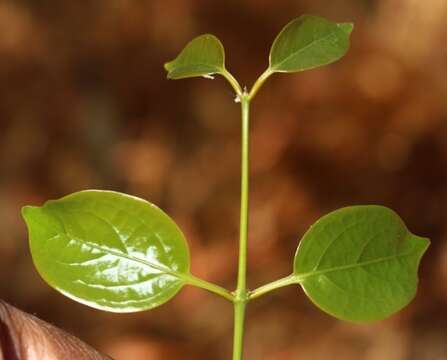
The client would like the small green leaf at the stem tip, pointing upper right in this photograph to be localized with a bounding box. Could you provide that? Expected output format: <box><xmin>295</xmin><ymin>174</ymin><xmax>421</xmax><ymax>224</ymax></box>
<box><xmin>269</xmin><ymin>15</ymin><xmax>353</xmax><ymax>72</ymax></box>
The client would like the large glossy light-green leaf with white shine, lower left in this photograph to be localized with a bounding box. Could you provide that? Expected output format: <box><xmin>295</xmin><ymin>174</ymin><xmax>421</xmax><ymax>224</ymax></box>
<box><xmin>22</xmin><ymin>190</ymin><xmax>189</xmax><ymax>312</ymax></box>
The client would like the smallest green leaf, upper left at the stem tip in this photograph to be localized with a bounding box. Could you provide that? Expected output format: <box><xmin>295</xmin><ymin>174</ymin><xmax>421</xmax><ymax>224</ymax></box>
<box><xmin>165</xmin><ymin>34</ymin><xmax>225</xmax><ymax>79</ymax></box>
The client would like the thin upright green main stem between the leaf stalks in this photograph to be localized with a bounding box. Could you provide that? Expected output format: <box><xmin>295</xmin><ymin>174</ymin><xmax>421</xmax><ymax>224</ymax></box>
<box><xmin>233</xmin><ymin>92</ymin><xmax>250</xmax><ymax>360</ymax></box>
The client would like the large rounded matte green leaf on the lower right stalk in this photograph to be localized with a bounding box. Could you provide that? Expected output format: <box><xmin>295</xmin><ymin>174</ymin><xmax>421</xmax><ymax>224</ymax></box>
<box><xmin>294</xmin><ymin>206</ymin><xmax>429</xmax><ymax>322</ymax></box>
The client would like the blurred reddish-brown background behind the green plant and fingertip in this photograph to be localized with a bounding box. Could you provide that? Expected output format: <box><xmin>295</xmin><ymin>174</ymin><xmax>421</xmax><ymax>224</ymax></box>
<box><xmin>0</xmin><ymin>0</ymin><xmax>447</xmax><ymax>360</ymax></box>
